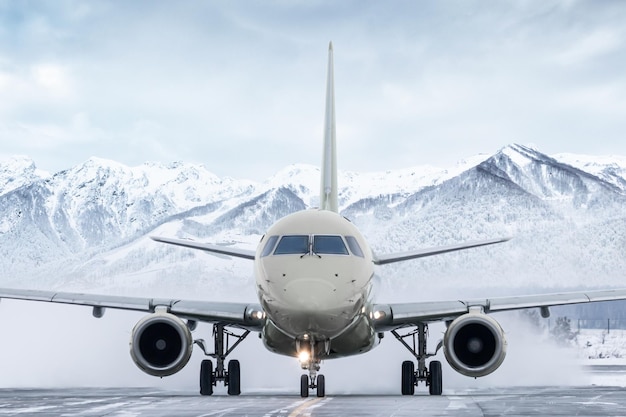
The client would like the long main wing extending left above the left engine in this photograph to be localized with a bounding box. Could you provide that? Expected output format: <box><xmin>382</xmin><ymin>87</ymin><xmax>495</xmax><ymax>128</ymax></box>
<box><xmin>0</xmin><ymin>288</ymin><xmax>263</xmax><ymax>330</ymax></box>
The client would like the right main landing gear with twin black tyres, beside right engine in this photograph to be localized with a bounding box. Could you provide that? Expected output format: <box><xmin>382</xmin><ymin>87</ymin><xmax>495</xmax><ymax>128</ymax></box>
<box><xmin>391</xmin><ymin>323</ymin><xmax>443</xmax><ymax>395</ymax></box>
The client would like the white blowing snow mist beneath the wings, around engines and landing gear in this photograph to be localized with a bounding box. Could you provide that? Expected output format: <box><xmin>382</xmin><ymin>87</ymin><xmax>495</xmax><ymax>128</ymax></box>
<box><xmin>0</xmin><ymin>300</ymin><xmax>589</xmax><ymax>395</ymax></box>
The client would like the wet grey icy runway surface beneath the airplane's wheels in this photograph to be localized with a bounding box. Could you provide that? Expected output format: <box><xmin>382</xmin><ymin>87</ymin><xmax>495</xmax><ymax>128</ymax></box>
<box><xmin>0</xmin><ymin>386</ymin><xmax>626</xmax><ymax>417</ymax></box>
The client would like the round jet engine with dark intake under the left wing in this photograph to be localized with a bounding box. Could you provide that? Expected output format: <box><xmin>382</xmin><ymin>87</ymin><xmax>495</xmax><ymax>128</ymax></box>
<box><xmin>130</xmin><ymin>313</ymin><xmax>193</xmax><ymax>377</ymax></box>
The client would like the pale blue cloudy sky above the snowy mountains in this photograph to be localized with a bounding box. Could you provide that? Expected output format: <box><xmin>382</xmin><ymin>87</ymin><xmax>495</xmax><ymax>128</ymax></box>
<box><xmin>0</xmin><ymin>0</ymin><xmax>626</xmax><ymax>180</ymax></box>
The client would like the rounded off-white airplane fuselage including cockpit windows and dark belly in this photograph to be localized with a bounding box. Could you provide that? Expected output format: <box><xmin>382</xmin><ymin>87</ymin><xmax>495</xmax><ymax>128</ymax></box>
<box><xmin>255</xmin><ymin>209</ymin><xmax>375</xmax><ymax>357</ymax></box>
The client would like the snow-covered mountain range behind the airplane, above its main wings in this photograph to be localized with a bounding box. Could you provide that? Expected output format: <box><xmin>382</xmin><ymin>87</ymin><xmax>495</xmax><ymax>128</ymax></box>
<box><xmin>0</xmin><ymin>145</ymin><xmax>626</xmax><ymax>300</ymax></box>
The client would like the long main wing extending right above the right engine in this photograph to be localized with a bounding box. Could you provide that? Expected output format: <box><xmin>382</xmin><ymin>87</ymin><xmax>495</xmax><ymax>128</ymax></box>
<box><xmin>372</xmin><ymin>288</ymin><xmax>626</xmax><ymax>331</ymax></box>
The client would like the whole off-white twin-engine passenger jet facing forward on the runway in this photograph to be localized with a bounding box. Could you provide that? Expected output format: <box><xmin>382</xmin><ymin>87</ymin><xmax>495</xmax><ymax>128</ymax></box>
<box><xmin>0</xmin><ymin>42</ymin><xmax>626</xmax><ymax>397</ymax></box>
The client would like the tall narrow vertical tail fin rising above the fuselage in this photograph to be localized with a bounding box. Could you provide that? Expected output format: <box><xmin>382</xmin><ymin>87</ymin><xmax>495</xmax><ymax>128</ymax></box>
<box><xmin>320</xmin><ymin>42</ymin><xmax>339</xmax><ymax>213</ymax></box>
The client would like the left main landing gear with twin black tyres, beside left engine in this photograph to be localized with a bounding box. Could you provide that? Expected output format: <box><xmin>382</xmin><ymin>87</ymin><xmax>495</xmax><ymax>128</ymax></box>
<box><xmin>195</xmin><ymin>323</ymin><xmax>250</xmax><ymax>395</ymax></box>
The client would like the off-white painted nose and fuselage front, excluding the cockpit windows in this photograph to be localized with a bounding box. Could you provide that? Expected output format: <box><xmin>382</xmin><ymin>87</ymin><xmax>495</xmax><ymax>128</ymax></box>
<box><xmin>255</xmin><ymin>209</ymin><xmax>374</xmax><ymax>340</ymax></box>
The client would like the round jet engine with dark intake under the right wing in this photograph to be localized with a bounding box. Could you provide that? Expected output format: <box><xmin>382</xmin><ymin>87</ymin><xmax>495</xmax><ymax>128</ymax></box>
<box><xmin>443</xmin><ymin>313</ymin><xmax>506</xmax><ymax>377</ymax></box>
